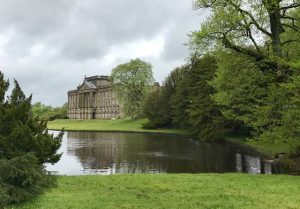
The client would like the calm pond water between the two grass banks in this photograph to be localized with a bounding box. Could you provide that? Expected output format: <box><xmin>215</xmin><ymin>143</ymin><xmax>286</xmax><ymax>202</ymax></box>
<box><xmin>47</xmin><ymin>132</ymin><xmax>271</xmax><ymax>175</ymax></box>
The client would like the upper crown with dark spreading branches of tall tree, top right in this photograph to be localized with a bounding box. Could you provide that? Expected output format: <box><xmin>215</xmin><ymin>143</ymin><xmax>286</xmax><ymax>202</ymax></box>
<box><xmin>192</xmin><ymin>0</ymin><xmax>300</xmax><ymax>76</ymax></box>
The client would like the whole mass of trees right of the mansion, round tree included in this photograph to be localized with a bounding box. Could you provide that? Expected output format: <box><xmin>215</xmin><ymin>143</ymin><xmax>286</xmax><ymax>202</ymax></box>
<box><xmin>112</xmin><ymin>0</ymin><xmax>300</xmax><ymax>154</ymax></box>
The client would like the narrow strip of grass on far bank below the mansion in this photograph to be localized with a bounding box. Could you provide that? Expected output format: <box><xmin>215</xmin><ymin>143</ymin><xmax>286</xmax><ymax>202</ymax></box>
<box><xmin>48</xmin><ymin>119</ymin><xmax>188</xmax><ymax>135</ymax></box>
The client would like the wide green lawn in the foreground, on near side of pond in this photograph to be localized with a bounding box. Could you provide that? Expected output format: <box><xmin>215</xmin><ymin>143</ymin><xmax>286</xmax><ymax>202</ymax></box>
<box><xmin>7</xmin><ymin>174</ymin><xmax>300</xmax><ymax>209</ymax></box>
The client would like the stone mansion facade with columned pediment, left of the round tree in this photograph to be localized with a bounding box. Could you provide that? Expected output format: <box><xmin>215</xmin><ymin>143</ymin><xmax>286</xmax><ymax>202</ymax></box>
<box><xmin>68</xmin><ymin>76</ymin><xmax>122</xmax><ymax>119</ymax></box>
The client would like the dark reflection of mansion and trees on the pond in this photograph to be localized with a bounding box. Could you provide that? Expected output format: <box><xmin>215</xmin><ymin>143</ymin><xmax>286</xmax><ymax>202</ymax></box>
<box><xmin>67</xmin><ymin>132</ymin><xmax>260</xmax><ymax>173</ymax></box>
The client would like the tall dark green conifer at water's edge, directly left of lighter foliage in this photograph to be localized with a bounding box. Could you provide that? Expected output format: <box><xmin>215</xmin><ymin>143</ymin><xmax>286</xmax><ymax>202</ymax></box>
<box><xmin>186</xmin><ymin>55</ymin><xmax>224</xmax><ymax>141</ymax></box>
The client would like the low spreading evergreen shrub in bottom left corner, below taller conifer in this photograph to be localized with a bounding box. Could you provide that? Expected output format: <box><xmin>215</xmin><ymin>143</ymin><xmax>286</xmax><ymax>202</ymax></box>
<box><xmin>0</xmin><ymin>154</ymin><xmax>55</xmax><ymax>207</ymax></box>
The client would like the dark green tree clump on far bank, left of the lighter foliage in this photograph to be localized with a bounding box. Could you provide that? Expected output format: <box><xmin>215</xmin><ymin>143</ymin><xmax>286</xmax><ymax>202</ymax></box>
<box><xmin>144</xmin><ymin>55</ymin><xmax>224</xmax><ymax>140</ymax></box>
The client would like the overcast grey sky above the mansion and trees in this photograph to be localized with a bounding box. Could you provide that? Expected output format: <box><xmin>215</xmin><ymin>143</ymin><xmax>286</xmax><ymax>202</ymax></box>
<box><xmin>0</xmin><ymin>0</ymin><xmax>207</xmax><ymax>106</ymax></box>
